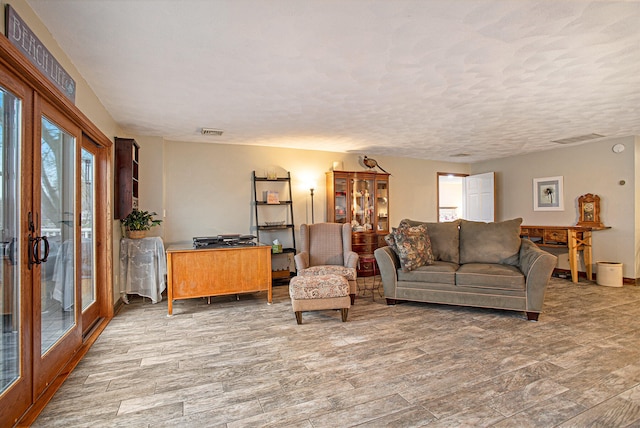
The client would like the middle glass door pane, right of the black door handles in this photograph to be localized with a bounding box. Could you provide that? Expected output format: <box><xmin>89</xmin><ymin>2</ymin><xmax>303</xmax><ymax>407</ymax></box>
<box><xmin>40</xmin><ymin>117</ymin><xmax>76</xmax><ymax>355</ymax></box>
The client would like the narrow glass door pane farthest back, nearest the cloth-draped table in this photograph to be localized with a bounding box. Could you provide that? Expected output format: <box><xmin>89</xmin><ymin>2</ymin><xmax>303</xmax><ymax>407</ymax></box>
<box><xmin>80</xmin><ymin>148</ymin><xmax>96</xmax><ymax>311</ymax></box>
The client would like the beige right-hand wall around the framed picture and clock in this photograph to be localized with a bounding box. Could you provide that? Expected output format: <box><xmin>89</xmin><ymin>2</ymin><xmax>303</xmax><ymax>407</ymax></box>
<box><xmin>471</xmin><ymin>137</ymin><xmax>640</xmax><ymax>278</ymax></box>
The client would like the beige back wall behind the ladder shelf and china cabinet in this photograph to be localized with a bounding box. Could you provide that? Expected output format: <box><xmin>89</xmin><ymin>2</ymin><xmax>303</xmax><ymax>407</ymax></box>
<box><xmin>159</xmin><ymin>141</ymin><xmax>468</xmax><ymax>244</ymax></box>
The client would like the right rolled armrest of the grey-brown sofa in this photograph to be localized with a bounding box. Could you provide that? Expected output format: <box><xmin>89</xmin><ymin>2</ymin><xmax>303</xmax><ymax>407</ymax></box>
<box><xmin>520</xmin><ymin>239</ymin><xmax>558</xmax><ymax>312</ymax></box>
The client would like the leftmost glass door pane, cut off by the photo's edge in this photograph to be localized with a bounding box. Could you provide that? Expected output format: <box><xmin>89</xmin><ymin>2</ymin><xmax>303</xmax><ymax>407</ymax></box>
<box><xmin>0</xmin><ymin>88</ymin><xmax>24</xmax><ymax>394</ymax></box>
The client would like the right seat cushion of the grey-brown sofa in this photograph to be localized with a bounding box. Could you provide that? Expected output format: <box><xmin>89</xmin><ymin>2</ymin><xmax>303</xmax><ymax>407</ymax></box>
<box><xmin>456</xmin><ymin>263</ymin><xmax>525</xmax><ymax>290</ymax></box>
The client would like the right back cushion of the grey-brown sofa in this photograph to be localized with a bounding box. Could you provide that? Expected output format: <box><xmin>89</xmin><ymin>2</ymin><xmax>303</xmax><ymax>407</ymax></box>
<box><xmin>460</xmin><ymin>218</ymin><xmax>522</xmax><ymax>266</ymax></box>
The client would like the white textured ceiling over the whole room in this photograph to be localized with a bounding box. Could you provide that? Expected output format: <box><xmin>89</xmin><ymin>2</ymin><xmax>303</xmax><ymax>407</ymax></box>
<box><xmin>27</xmin><ymin>0</ymin><xmax>640</xmax><ymax>162</ymax></box>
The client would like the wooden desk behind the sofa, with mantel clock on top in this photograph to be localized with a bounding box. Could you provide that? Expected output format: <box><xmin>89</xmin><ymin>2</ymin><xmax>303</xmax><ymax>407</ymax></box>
<box><xmin>520</xmin><ymin>226</ymin><xmax>597</xmax><ymax>282</ymax></box>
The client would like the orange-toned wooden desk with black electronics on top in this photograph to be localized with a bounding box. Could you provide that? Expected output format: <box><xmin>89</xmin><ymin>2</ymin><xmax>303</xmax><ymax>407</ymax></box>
<box><xmin>167</xmin><ymin>245</ymin><xmax>272</xmax><ymax>315</ymax></box>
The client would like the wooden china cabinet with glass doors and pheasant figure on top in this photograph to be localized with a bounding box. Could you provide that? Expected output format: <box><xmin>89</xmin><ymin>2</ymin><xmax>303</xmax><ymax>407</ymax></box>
<box><xmin>327</xmin><ymin>171</ymin><xmax>389</xmax><ymax>276</ymax></box>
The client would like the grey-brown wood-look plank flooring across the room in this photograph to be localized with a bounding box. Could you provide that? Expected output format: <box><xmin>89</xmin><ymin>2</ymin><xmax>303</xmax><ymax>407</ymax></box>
<box><xmin>34</xmin><ymin>278</ymin><xmax>640</xmax><ymax>428</ymax></box>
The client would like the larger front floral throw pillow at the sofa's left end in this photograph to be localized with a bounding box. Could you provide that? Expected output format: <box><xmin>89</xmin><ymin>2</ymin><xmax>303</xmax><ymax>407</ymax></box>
<box><xmin>393</xmin><ymin>223</ymin><xmax>434</xmax><ymax>272</ymax></box>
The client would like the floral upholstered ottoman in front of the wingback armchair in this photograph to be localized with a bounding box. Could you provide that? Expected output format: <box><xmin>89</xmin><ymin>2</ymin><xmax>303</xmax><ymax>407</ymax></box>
<box><xmin>289</xmin><ymin>274</ymin><xmax>351</xmax><ymax>324</ymax></box>
